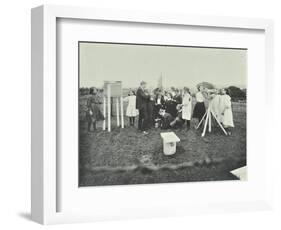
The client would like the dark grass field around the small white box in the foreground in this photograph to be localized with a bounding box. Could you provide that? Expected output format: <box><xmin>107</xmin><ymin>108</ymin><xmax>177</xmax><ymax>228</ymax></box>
<box><xmin>79</xmin><ymin>99</ymin><xmax>246</xmax><ymax>186</ymax></box>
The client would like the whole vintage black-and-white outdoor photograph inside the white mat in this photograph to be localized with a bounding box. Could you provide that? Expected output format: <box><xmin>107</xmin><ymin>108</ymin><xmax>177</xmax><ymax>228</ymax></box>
<box><xmin>77</xmin><ymin>41</ymin><xmax>247</xmax><ymax>187</ymax></box>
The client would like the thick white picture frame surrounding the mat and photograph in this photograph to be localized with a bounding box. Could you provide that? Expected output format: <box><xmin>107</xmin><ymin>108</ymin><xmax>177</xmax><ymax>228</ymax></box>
<box><xmin>31</xmin><ymin>5</ymin><xmax>276</xmax><ymax>224</ymax></box>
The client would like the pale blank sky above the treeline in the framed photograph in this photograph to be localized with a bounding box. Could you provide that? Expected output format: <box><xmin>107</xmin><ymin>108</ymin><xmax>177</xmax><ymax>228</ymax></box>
<box><xmin>79</xmin><ymin>42</ymin><xmax>247</xmax><ymax>88</ymax></box>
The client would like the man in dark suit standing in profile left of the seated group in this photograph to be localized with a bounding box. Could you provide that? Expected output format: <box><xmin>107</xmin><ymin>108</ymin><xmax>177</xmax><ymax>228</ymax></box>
<box><xmin>136</xmin><ymin>81</ymin><xmax>150</xmax><ymax>134</ymax></box>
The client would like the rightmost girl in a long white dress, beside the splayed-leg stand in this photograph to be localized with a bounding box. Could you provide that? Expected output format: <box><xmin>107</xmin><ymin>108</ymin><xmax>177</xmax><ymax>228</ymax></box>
<box><xmin>220</xmin><ymin>89</ymin><xmax>234</xmax><ymax>135</ymax></box>
